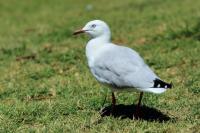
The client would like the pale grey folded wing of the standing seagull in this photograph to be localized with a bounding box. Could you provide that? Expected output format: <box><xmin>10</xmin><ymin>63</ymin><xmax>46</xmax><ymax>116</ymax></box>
<box><xmin>91</xmin><ymin>46</ymin><xmax>158</xmax><ymax>88</ymax></box>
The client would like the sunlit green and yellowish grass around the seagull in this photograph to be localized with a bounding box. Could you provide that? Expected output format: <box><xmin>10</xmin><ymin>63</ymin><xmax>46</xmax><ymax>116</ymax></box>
<box><xmin>0</xmin><ymin>0</ymin><xmax>200</xmax><ymax>133</ymax></box>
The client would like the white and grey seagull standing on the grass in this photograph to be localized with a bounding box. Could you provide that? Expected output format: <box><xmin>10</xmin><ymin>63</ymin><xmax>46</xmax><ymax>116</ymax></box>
<box><xmin>73</xmin><ymin>20</ymin><xmax>172</xmax><ymax>117</ymax></box>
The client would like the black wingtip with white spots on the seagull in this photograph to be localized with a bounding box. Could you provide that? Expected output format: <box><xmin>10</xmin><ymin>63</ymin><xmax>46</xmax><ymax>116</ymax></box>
<box><xmin>153</xmin><ymin>78</ymin><xmax>173</xmax><ymax>89</ymax></box>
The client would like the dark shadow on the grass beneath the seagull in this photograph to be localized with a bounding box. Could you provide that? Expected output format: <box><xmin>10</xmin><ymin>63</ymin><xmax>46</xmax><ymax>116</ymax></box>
<box><xmin>100</xmin><ymin>104</ymin><xmax>173</xmax><ymax>122</ymax></box>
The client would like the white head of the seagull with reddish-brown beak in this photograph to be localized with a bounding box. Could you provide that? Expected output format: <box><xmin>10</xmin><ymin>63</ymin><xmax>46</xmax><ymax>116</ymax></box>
<box><xmin>73</xmin><ymin>20</ymin><xmax>111</xmax><ymax>39</ymax></box>
